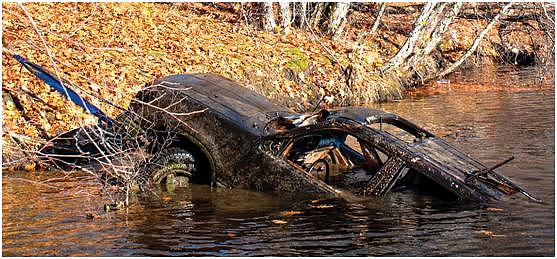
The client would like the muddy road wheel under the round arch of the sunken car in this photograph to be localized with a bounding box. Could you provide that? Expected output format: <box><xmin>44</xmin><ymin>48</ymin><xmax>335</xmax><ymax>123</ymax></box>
<box><xmin>138</xmin><ymin>147</ymin><xmax>196</xmax><ymax>191</ymax></box>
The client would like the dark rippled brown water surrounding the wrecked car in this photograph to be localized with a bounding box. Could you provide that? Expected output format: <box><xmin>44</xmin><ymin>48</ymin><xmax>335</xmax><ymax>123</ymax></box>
<box><xmin>2</xmin><ymin>67</ymin><xmax>555</xmax><ymax>256</ymax></box>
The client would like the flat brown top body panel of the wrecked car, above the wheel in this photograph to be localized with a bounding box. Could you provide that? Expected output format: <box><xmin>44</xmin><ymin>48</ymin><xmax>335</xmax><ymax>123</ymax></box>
<box><xmin>154</xmin><ymin>73</ymin><xmax>292</xmax><ymax>135</ymax></box>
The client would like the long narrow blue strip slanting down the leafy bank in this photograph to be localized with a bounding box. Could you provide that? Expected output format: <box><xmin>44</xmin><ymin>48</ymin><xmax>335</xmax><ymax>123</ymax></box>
<box><xmin>14</xmin><ymin>54</ymin><xmax>114</xmax><ymax>125</ymax></box>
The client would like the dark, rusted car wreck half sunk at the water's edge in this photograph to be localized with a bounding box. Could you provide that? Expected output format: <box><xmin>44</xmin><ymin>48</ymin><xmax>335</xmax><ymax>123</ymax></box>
<box><xmin>38</xmin><ymin>74</ymin><xmax>539</xmax><ymax>202</ymax></box>
